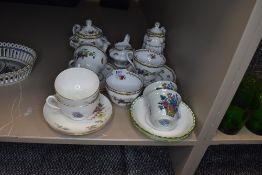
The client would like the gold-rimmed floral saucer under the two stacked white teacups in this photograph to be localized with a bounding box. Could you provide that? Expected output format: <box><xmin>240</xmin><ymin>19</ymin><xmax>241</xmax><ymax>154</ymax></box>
<box><xmin>43</xmin><ymin>94</ymin><xmax>112</xmax><ymax>135</ymax></box>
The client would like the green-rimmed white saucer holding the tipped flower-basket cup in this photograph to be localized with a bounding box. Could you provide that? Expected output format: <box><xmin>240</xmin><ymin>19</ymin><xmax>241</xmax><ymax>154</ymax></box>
<box><xmin>130</xmin><ymin>97</ymin><xmax>195</xmax><ymax>142</ymax></box>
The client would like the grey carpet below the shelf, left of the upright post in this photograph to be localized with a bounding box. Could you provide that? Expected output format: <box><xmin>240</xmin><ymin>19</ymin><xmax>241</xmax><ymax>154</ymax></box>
<box><xmin>0</xmin><ymin>143</ymin><xmax>175</xmax><ymax>175</ymax></box>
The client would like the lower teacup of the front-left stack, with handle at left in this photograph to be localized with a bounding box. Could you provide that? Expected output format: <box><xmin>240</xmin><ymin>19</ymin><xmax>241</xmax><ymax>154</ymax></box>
<box><xmin>46</xmin><ymin>95</ymin><xmax>99</xmax><ymax>120</ymax></box>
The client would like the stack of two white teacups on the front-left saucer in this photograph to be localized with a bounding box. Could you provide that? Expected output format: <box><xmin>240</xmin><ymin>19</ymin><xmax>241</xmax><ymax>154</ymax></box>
<box><xmin>46</xmin><ymin>68</ymin><xmax>99</xmax><ymax>120</ymax></box>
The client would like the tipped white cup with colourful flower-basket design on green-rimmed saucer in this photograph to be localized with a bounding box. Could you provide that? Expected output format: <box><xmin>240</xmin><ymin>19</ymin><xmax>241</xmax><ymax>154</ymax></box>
<box><xmin>145</xmin><ymin>89</ymin><xmax>182</xmax><ymax>131</ymax></box>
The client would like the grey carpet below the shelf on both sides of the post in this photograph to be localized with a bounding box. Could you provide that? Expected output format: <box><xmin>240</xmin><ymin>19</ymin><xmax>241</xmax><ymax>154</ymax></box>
<box><xmin>0</xmin><ymin>143</ymin><xmax>262</xmax><ymax>175</ymax></box>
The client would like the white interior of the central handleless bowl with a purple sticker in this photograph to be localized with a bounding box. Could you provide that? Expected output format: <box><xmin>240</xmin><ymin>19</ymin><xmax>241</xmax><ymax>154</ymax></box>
<box><xmin>106</xmin><ymin>69</ymin><xmax>143</xmax><ymax>93</ymax></box>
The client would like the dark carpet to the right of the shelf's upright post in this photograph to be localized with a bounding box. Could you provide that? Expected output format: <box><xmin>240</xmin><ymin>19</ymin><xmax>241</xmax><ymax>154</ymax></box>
<box><xmin>195</xmin><ymin>145</ymin><xmax>262</xmax><ymax>175</ymax></box>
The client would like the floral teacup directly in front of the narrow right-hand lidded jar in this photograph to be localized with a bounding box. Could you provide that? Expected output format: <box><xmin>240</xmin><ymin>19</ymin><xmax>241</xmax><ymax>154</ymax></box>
<box><xmin>134</xmin><ymin>49</ymin><xmax>166</xmax><ymax>82</ymax></box>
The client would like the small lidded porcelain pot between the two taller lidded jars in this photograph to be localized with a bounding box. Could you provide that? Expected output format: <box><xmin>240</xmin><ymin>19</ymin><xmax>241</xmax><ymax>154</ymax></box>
<box><xmin>109</xmin><ymin>34</ymin><xmax>134</xmax><ymax>68</ymax></box>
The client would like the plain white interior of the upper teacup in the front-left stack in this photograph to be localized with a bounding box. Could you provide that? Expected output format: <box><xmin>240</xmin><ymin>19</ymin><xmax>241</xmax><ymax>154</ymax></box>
<box><xmin>55</xmin><ymin>68</ymin><xmax>99</xmax><ymax>100</ymax></box>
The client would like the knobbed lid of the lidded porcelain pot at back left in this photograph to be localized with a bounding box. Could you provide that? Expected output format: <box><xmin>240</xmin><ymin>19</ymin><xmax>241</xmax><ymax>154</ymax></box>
<box><xmin>77</xmin><ymin>19</ymin><xmax>103</xmax><ymax>38</ymax></box>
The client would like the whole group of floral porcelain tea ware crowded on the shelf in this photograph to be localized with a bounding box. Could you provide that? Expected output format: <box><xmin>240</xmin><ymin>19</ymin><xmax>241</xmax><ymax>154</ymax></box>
<box><xmin>43</xmin><ymin>19</ymin><xmax>195</xmax><ymax>141</ymax></box>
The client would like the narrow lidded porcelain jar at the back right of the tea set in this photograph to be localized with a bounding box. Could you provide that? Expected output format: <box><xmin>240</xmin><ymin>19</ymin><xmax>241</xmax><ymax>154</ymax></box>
<box><xmin>142</xmin><ymin>22</ymin><xmax>166</xmax><ymax>54</ymax></box>
